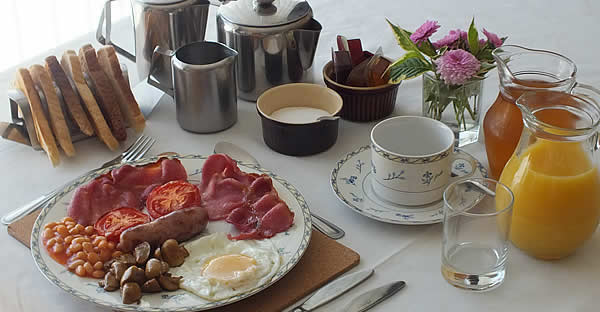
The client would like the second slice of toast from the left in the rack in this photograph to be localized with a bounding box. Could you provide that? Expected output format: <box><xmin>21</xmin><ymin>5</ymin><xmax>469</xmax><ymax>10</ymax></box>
<box><xmin>29</xmin><ymin>64</ymin><xmax>75</xmax><ymax>157</ymax></box>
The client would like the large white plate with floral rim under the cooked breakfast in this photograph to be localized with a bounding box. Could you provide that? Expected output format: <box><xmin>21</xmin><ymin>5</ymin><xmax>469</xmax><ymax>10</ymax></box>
<box><xmin>31</xmin><ymin>155</ymin><xmax>312</xmax><ymax>312</ymax></box>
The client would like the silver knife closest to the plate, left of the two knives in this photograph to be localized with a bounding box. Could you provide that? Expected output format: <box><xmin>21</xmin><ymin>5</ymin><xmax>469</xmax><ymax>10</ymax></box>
<box><xmin>292</xmin><ymin>269</ymin><xmax>374</xmax><ymax>312</ymax></box>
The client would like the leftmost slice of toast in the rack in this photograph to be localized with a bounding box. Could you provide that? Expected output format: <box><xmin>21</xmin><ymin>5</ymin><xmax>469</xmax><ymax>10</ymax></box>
<box><xmin>16</xmin><ymin>68</ymin><xmax>60</xmax><ymax>167</ymax></box>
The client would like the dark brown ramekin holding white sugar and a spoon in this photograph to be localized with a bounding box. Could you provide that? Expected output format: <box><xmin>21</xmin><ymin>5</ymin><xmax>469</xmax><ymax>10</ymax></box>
<box><xmin>256</xmin><ymin>83</ymin><xmax>343</xmax><ymax>156</ymax></box>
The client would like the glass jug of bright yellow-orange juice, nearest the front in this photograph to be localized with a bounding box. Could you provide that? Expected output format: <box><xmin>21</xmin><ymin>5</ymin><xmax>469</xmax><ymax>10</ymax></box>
<box><xmin>497</xmin><ymin>91</ymin><xmax>600</xmax><ymax>259</ymax></box>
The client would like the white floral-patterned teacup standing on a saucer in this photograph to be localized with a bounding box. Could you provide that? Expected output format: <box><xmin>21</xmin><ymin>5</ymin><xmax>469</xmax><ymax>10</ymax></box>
<box><xmin>371</xmin><ymin>116</ymin><xmax>477</xmax><ymax>206</ymax></box>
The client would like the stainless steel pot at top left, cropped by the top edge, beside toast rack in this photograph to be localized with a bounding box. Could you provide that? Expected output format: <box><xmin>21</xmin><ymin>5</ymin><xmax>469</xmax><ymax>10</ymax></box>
<box><xmin>96</xmin><ymin>0</ymin><xmax>210</xmax><ymax>83</ymax></box>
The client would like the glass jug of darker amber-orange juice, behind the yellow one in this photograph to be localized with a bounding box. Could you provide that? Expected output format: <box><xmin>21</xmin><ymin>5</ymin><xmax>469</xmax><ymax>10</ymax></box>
<box><xmin>483</xmin><ymin>45</ymin><xmax>598</xmax><ymax>179</ymax></box>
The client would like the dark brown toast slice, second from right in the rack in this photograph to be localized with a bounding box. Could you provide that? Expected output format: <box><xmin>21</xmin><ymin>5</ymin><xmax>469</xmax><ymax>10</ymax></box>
<box><xmin>79</xmin><ymin>44</ymin><xmax>127</xmax><ymax>141</ymax></box>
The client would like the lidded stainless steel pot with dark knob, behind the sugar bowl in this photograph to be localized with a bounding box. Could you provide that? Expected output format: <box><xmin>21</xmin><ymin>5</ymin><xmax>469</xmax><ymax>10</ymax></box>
<box><xmin>217</xmin><ymin>0</ymin><xmax>322</xmax><ymax>101</ymax></box>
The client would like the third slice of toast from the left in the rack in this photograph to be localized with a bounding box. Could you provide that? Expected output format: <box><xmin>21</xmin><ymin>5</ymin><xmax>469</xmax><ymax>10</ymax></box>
<box><xmin>45</xmin><ymin>55</ymin><xmax>94</xmax><ymax>136</ymax></box>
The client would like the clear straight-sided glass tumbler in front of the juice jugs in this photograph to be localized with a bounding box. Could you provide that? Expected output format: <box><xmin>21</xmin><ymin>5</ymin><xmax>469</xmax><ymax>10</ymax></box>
<box><xmin>442</xmin><ymin>178</ymin><xmax>514</xmax><ymax>291</ymax></box>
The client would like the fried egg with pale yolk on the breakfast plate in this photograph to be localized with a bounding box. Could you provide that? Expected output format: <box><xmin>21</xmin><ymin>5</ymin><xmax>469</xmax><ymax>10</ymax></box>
<box><xmin>170</xmin><ymin>233</ymin><xmax>281</xmax><ymax>301</ymax></box>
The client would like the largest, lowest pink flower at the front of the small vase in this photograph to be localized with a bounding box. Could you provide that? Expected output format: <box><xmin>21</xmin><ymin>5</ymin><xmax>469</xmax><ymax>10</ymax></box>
<box><xmin>434</xmin><ymin>49</ymin><xmax>481</xmax><ymax>85</ymax></box>
